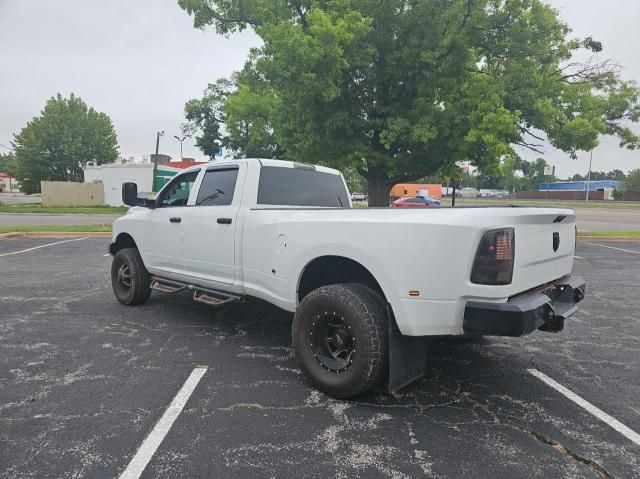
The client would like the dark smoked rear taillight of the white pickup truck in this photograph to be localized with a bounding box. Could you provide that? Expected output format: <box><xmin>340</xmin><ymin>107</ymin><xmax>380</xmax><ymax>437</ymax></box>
<box><xmin>471</xmin><ymin>228</ymin><xmax>515</xmax><ymax>285</ymax></box>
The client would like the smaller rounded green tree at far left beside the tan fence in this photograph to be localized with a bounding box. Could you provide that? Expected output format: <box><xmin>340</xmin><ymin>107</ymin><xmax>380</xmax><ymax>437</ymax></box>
<box><xmin>12</xmin><ymin>94</ymin><xmax>118</xmax><ymax>194</ymax></box>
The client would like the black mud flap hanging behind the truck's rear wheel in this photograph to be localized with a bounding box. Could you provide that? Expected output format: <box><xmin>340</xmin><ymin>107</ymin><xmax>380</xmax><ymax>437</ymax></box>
<box><xmin>387</xmin><ymin>321</ymin><xmax>428</xmax><ymax>393</ymax></box>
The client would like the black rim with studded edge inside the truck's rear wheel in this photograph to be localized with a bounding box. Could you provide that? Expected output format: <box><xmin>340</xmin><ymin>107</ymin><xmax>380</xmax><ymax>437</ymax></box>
<box><xmin>309</xmin><ymin>312</ymin><xmax>356</xmax><ymax>373</ymax></box>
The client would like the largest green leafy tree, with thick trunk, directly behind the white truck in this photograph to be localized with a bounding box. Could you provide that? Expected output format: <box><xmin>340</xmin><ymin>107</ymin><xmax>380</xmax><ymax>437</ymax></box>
<box><xmin>178</xmin><ymin>0</ymin><xmax>640</xmax><ymax>206</ymax></box>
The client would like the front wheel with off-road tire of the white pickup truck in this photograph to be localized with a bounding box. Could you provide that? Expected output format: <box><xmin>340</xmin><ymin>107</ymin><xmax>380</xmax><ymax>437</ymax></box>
<box><xmin>111</xmin><ymin>248</ymin><xmax>151</xmax><ymax>306</ymax></box>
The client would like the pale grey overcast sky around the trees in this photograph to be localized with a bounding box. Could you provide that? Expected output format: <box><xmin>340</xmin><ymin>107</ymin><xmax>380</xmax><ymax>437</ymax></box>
<box><xmin>0</xmin><ymin>0</ymin><xmax>640</xmax><ymax>177</ymax></box>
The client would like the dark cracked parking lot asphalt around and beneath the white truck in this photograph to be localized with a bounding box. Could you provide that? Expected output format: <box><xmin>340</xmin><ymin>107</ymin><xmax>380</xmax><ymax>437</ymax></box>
<box><xmin>0</xmin><ymin>239</ymin><xmax>640</xmax><ymax>478</ymax></box>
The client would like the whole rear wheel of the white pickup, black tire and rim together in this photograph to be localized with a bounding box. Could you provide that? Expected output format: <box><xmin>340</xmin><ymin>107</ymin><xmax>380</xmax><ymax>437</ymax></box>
<box><xmin>292</xmin><ymin>284</ymin><xmax>388</xmax><ymax>399</ymax></box>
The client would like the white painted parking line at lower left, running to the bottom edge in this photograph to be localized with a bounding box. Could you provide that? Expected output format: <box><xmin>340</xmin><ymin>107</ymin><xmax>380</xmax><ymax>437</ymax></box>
<box><xmin>120</xmin><ymin>366</ymin><xmax>207</xmax><ymax>479</ymax></box>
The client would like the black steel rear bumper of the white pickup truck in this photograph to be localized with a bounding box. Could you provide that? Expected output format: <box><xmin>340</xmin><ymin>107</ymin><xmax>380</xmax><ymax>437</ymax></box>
<box><xmin>463</xmin><ymin>275</ymin><xmax>585</xmax><ymax>337</ymax></box>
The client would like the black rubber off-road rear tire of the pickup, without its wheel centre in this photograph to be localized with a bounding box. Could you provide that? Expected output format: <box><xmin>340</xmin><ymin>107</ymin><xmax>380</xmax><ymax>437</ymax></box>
<box><xmin>292</xmin><ymin>284</ymin><xmax>389</xmax><ymax>399</ymax></box>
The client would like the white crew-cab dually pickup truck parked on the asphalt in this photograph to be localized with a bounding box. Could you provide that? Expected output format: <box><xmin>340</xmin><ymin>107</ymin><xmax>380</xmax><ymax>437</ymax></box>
<box><xmin>109</xmin><ymin>159</ymin><xmax>585</xmax><ymax>398</ymax></box>
